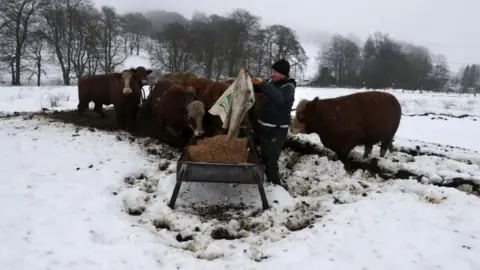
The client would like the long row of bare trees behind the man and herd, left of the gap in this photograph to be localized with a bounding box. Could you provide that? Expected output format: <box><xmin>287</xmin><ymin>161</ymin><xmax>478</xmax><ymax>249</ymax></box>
<box><xmin>0</xmin><ymin>0</ymin><xmax>307</xmax><ymax>85</ymax></box>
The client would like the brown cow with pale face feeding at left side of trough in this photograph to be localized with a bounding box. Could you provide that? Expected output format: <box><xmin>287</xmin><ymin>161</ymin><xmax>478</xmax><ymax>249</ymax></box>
<box><xmin>153</xmin><ymin>85</ymin><xmax>205</xmax><ymax>147</ymax></box>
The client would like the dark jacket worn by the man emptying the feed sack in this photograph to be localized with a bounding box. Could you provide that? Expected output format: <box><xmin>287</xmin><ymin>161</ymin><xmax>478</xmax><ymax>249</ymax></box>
<box><xmin>254</xmin><ymin>77</ymin><xmax>297</xmax><ymax>126</ymax></box>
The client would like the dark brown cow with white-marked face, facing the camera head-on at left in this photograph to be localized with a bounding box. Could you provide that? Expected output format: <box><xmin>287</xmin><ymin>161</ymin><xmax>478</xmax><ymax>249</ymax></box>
<box><xmin>109</xmin><ymin>69</ymin><xmax>142</xmax><ymax>130</ymax></box>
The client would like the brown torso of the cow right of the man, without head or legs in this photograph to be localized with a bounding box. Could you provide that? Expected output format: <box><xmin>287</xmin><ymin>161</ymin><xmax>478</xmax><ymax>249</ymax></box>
<box><xmin>315</xmin><ymin>91</ymin><xmax>401</xmax><ymax>151</ymax></box>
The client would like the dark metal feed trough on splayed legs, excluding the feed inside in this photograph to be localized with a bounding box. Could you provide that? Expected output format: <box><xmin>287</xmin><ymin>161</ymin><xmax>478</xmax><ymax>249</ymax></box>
<box><xmin>168</xmin><ymin>126</ymin><xmax>269</xmax><ymax>210</ymax></box>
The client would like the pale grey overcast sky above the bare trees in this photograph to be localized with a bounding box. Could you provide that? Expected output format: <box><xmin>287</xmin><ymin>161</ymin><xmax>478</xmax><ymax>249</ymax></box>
<box><xmin>93</xmin><ymin>0</ymin><xmax>480</xmax><ymax>77</ymax></box>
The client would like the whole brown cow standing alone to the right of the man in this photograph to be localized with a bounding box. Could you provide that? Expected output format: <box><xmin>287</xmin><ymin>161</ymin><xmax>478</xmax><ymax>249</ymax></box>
<box><xmin>291</xmin><ymin>91</ymin><xmax>402</xmax><ymax>170</ymax></box>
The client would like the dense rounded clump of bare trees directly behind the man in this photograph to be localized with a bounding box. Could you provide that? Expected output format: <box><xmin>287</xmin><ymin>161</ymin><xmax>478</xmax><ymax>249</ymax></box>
<box><xmin>148</xmin><ymin>9</ymin><xmax>308</xmax><ymax>79</ymax></box>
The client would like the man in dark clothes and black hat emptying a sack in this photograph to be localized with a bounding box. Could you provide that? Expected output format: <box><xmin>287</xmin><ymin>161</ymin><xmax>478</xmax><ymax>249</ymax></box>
<box><xmin>248</xmin><ymin>59</ymin><xmax>297</xmax><ymax>185</ymax></box>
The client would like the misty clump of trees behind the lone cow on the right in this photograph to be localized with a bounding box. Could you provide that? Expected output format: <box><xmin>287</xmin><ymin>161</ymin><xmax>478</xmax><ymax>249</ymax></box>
<box><xmin>315</xmin><ymin>33</ymin><xmax>450</xmax><ymax>90</ymax></box>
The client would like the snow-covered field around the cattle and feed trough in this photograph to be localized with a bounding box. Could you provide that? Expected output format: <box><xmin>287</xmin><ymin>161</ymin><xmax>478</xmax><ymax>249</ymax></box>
<box><xmin>0</xmin><ymin>81</ymin><xmax>480</xmax><ymax>270</ymax></box>
